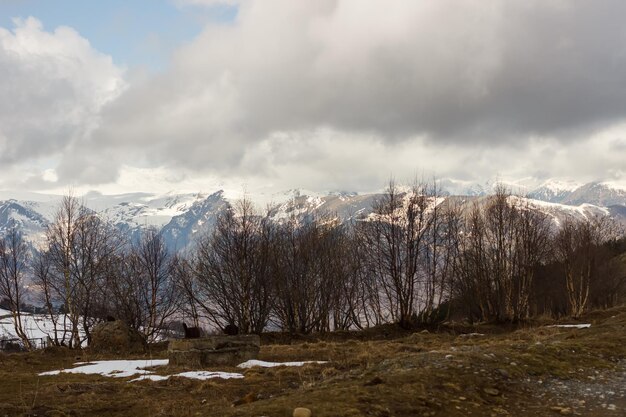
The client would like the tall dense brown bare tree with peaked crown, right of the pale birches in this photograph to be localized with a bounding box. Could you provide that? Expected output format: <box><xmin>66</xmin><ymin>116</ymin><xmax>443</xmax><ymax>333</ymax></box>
<box><xmin>456</xmin><ymin>186</ymin><xmax>551</xmax><ymax>321</ymax></box>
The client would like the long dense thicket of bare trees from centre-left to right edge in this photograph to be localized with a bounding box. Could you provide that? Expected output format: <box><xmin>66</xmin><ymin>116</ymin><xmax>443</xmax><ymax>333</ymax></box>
<box><xmin>184</xmin><ymin>182</ymin><xmax>626</xmax><ymax>333</ymax></box>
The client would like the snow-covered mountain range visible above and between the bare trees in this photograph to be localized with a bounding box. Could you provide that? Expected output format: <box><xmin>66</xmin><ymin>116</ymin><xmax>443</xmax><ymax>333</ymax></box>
<box><xmin>0</xmin><ymin>180</ymin><xmax>626</xmax><ymax>251</ymax></box>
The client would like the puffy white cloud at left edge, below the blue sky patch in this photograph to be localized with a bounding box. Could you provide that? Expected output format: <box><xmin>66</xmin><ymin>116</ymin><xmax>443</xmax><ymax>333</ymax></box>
<box><xmin>0</xmin><ymin>17</ymin><xmax>124</xmax><ymax>184</ymax></box>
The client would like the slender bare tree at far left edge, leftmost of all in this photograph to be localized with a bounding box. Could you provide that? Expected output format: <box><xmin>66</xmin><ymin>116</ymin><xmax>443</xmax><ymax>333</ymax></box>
<box><xmin>0</xmin><ymin>225</ymin><xmax>33</xmax><ymax>350</ymax></box>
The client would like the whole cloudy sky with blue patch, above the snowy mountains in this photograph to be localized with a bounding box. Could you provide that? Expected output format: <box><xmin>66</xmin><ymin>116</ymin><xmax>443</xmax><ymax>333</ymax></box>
<box><xmin>0</xmin><ymin>0</ymin><xmax>626</xmax><ymax>193</ymax></box>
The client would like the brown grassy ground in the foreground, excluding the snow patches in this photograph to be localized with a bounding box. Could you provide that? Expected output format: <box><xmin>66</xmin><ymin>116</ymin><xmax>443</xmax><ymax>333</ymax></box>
<box><xmin>0</xmin><ymin>307</ymin><xmax>626</xmax><ymax>417</ymax></box>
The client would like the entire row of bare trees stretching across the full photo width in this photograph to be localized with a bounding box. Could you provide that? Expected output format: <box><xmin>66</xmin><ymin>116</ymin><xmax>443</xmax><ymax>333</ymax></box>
<box><xmin>0</xmin><ymin>182</ymin><xmax>626</xmax><ymax>347</ymax></box>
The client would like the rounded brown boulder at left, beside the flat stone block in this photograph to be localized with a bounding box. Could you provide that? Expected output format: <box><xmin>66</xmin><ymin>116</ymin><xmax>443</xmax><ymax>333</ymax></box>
<box><xmin>89</xmin><ymin>320</ymin><xmax>147</xmax><ymax>353</ymax></box>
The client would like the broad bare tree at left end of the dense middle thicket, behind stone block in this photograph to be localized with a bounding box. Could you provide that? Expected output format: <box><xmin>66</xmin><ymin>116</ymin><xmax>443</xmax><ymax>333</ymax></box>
<box><xmin>193</xmin><ymin>198</ymin><xmax>272</xmax><ymax>333</ymax></box>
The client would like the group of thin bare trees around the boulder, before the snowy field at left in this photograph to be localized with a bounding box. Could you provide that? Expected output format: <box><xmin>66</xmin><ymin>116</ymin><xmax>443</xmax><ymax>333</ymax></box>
<box><xmin>25</xmin><ymin>196</ymin><xmax>179</xmax><ymax>347</ymax></box>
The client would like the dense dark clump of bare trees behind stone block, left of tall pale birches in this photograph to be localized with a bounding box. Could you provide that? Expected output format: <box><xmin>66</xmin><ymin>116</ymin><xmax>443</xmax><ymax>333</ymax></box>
<box><xmin>179</xmin><ymin>199</ymin><xmax>352</xmax><ymax>333</ymax></box>
